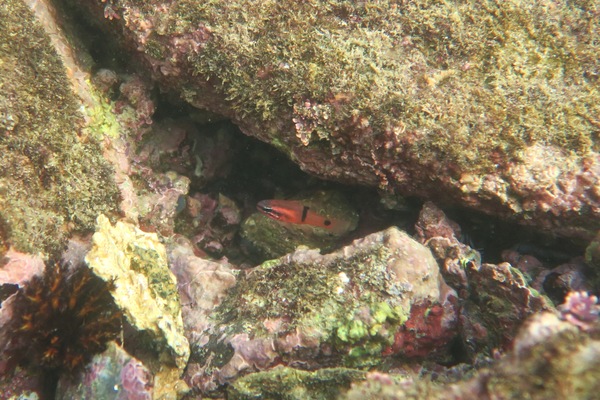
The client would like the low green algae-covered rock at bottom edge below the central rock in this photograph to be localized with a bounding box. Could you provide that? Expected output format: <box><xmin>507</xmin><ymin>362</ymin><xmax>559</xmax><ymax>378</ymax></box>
<box><xmin>227</xmin><ymin>367</ymin><xmax>365</xmax><ymax>400</ymax></box>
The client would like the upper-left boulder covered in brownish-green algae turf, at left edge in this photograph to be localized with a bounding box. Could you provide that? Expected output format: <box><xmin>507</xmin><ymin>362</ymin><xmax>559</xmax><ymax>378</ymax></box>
<box><xmin>0</xmin><ymin>0</ymin><xmax>119</xmax><ymax>255</ymax></box>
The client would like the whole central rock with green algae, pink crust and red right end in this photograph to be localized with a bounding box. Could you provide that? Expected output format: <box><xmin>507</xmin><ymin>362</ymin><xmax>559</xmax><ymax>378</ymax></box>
<box><xmin>187</xmin><ymin>228</ymin><xmax>456</xmax><ymax>392</ymax></box>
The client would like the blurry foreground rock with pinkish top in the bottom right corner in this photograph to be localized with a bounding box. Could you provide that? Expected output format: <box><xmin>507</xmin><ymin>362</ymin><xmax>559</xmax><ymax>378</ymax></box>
<box><xmin>338</xmin><ymin>313</ymin><xmax>600</xmax><ymax>400</ymax></box>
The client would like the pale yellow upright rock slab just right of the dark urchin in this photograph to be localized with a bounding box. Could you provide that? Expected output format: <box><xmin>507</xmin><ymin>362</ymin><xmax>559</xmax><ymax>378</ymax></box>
<box><xmin>85</xmin><ymin>215</ymin><xmax>189</xmax><ymax>396</ymax></box>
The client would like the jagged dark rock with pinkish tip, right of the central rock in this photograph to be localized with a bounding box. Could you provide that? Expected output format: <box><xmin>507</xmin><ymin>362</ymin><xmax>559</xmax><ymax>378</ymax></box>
<box><xmin>416</xmin><ymin>202</ymin><xmax>552</xmax><ymax>361</ymax></box>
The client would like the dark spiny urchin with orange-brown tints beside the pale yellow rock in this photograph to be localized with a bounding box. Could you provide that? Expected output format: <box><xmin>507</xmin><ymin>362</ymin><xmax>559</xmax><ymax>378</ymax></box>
<box><xmin>5</xmin><ymin>264</ymin><xmax>121</xmax><ymax>372</ymax></box>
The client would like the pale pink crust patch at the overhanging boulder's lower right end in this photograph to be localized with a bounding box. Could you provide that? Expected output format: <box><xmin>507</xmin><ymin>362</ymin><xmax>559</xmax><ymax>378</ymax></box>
<box><xmin>459</xmin><ymin>148</ymin><xmax>600</xmax><ymax>239</ymax></box>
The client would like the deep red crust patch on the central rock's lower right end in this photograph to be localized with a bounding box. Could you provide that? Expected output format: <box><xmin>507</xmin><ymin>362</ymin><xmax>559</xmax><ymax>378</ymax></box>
<box><xmin>382</xmin><ymin>301</ymin><xmax>456</xmax><ymax>358</ymax></box>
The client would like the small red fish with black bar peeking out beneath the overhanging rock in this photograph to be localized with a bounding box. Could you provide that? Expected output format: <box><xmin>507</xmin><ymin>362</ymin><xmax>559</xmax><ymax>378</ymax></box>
<box><xmin>256</xmin><ymin>200</ymin><xmax>348</xmax><ymax>234</ymax></box>
